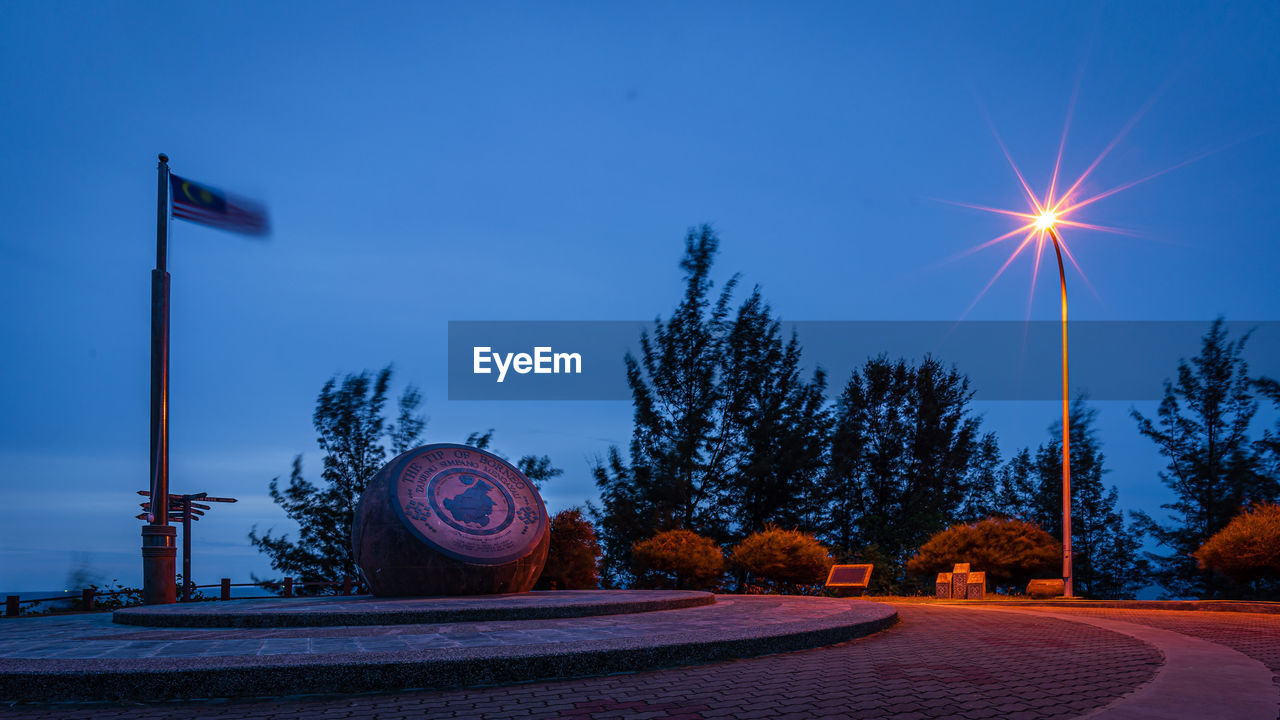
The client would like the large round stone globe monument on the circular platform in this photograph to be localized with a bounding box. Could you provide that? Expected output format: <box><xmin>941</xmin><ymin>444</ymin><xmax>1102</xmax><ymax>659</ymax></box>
<box><xmin>351</xmin><ymin>443</ymin><xmax>550</xmax><ymax>596</ymax></box>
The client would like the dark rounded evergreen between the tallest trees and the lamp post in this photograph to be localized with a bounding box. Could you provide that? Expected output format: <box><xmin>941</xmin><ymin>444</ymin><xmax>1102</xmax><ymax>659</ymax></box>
<box><xmin>826</xmin><ymin>356</ymin><xmax>979</xmax><ymax>575</ymax></box>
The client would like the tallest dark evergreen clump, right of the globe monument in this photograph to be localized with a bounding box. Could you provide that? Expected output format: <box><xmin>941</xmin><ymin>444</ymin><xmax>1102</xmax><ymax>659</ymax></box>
<box><xmin>589</xmin><ymin>225</ymin><xmax>829</xmax><ymax>583</ymax></box>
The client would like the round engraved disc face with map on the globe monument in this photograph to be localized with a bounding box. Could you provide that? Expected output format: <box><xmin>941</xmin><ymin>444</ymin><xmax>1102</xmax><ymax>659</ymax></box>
<box><xmin>393</xmin><ymin>446</ymin><xmax>548</xmax><ymax>564</ymax></box>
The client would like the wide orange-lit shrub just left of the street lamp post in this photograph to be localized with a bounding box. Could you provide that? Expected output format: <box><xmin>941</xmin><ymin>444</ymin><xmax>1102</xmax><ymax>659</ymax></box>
<box><xmin>906</xmin><ymin>518</ymin><xmax>1062</xmax><ymax>585</ymax></box>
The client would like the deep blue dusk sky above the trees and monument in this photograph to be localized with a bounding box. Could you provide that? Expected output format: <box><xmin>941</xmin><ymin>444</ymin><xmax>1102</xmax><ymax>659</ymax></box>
<box><xmin>0</xmin><ymin>3</ymin><xmax>1280</xmax><ymax>591</ymax></box>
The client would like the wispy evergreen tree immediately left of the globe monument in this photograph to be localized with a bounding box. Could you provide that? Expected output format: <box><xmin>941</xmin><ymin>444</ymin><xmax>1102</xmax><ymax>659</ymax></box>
<box><xmin>248</xmin><ymin>365</ymin><xmax>426</xmax><ymax>582</ymax></box>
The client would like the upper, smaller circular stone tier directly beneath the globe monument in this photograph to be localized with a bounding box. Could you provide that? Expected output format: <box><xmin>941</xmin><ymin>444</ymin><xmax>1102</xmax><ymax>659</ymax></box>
<box><xmin>114</xmin><ymin>591</ymin><xmax>716</xmax><ymax>628</ymax></box>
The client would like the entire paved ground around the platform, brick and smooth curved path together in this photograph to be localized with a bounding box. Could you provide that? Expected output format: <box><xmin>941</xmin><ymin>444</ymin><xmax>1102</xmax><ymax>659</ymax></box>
<box><xmin>0</xmin><ymin>597</ymin><xmax>1280</xmax><ymax>720</ymax></box>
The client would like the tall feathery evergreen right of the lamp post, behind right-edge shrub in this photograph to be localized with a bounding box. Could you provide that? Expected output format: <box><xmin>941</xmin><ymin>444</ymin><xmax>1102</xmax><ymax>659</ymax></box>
<box><xmin>1133</xmin><ymin>318</ymin><xmax>1280</xmax><ymax>597</ymax></box>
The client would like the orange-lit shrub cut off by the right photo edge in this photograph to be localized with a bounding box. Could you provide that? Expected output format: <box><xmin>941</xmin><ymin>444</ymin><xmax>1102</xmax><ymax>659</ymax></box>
<box><xmin>1193</xmin><ymin>502</ymin><xmax>1280</xmax><ymax>583</ymax></box>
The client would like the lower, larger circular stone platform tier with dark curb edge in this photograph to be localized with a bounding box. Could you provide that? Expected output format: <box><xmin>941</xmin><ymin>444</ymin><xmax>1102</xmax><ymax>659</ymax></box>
<box><xmin>0</xmin><ymin>591</ymin><xmax>897</xmax><ymax>702</ymax></box>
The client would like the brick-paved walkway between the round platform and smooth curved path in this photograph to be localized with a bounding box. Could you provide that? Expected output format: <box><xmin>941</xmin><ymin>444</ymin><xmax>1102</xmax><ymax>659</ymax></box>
<box><xmin>0</xmin><ymin>603</ymin><xmax>1161</xmax><ymax>720</ymax></box>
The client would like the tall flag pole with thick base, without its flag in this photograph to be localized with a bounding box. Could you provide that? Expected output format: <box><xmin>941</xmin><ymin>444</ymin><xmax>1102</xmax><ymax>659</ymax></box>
<box><xmin>142</xmin><ymin>152</ymin><xmax>178</xmax><ymax>605</ymax></box>
